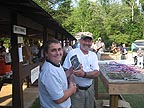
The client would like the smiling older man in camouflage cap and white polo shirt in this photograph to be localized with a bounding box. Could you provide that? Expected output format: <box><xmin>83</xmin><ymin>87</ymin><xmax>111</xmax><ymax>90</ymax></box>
<box><xmin>63</xmin><ymin>34</ymin><xmax>99</xmax><ymax>108</ymax></box>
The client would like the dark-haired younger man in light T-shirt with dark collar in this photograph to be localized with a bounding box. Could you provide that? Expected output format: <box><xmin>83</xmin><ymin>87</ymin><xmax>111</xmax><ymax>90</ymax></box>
<box><xmin>38</xmin><ymin>39</ymin><xmax>76</xmax><ymax>108</ymax></box>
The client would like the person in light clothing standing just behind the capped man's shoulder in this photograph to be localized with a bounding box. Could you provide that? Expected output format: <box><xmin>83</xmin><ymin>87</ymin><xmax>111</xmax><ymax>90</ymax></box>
<box><xmin>95</xmin><ymin>37</ymin><xmax>105</xmax><ymax>60</ymax></box>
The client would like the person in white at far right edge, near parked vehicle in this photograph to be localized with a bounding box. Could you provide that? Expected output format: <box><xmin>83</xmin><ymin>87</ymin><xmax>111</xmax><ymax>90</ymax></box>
<box><xmin>137</xmin><ymin>48</ymin><xmax>144</xmax><ymax>68</ymax></box>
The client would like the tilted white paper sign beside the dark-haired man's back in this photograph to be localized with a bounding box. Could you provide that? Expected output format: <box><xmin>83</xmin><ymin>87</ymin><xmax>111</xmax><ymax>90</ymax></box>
<box><xmin>31</xmin><ymin>66</ymin><xmax>40</xmax><ymax>84</ymax></box>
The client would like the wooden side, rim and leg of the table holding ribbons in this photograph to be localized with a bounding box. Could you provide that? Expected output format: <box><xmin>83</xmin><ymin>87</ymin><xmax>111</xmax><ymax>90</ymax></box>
<box><xmin>100</xmin><ymin>66</ymin><xmax>144</xmax><ymax>108</ymax></box>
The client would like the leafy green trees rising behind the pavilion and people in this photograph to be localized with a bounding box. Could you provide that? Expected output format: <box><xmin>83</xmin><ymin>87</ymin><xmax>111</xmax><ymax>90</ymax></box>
<box><xmin>34</xmin><ymin>0</ymin><xmax>144</xmax><ymax>47</ymax></box>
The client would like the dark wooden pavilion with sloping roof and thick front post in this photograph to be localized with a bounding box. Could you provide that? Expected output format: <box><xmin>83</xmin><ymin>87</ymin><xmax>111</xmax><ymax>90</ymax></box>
<box><xmin>0</xmin><ymin>0</ymin><xmax>76</xmax><ymax>108</ymax></box>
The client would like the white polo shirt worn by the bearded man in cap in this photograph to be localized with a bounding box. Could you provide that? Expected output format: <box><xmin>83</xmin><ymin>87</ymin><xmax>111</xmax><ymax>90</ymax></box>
<box><xmin>63</xmin><ymin>48</ymin><xmax>99</xmax><ymax>87</ymax></box>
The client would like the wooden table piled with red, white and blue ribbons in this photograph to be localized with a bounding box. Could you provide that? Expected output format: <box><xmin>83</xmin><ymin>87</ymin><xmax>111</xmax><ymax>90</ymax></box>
<box><xmin>100</xmin><ymin>61</ymin><xmax>144</xmax><ymax>108</ymax></box>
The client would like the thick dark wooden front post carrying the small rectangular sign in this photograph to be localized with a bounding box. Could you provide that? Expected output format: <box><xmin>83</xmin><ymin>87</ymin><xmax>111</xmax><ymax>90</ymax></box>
<box><xmin>11</xmin><ymin>13</ymin><xmax>24</xmax><ymax>108</ymax></box>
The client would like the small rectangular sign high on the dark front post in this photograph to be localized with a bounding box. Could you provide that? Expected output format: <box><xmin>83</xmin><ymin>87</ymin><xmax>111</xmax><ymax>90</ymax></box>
<box><xmin>13</xmin><ymin>25</ymin><xmax>26</xmax><ymax>35</ymax></box>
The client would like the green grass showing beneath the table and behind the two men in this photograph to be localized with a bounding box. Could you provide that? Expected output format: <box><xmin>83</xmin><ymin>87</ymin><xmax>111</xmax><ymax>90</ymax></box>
<box><xmin>31</xmin><ymin>79</ymin><xmax>144</xmax><ymax>108</ymax></box>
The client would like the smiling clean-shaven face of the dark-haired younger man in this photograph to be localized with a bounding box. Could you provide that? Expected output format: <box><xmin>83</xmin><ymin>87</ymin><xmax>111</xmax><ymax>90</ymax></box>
<box><xmin>46</xmin><ymin>43</ymin><xmax>63</xmax><ymax>64</ymax></box>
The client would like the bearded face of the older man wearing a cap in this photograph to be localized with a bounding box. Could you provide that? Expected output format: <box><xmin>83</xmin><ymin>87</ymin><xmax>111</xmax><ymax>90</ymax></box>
<box><xmin>80</xmin><ymin>38</ymin><xmax>93</xmax><ymax>51</ymax></box>
